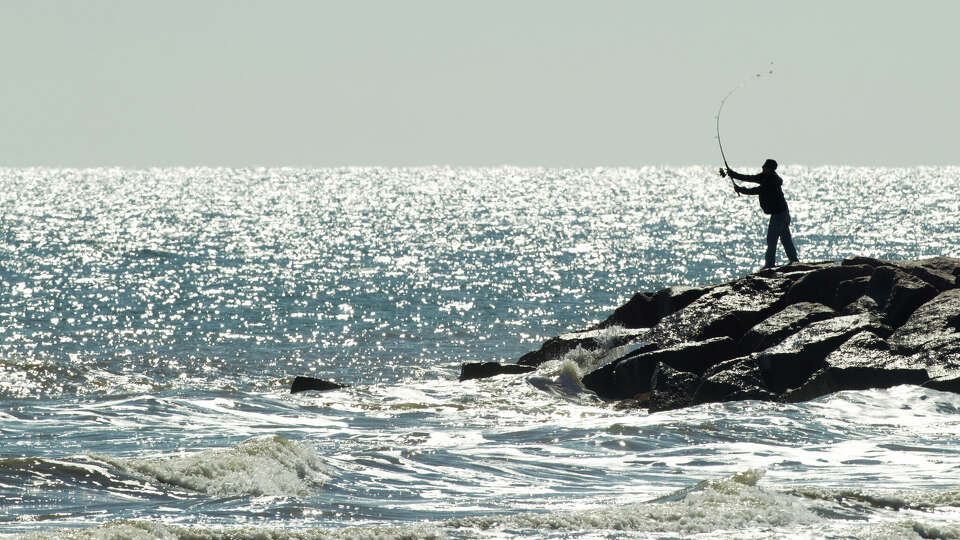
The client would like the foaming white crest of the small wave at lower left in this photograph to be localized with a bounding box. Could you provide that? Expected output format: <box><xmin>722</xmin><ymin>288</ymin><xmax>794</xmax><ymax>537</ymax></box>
<box><xmin>94</xmin><ymin>435</ymin><xmax>329</xmax><ymax>497</ymax></box>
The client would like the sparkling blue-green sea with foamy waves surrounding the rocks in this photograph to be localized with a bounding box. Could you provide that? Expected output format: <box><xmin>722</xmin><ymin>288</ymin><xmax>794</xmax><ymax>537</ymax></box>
<box><xmin>0</xmin><ymin>166</ymin><xmax>960</xmax><ymax>539</ymax></box>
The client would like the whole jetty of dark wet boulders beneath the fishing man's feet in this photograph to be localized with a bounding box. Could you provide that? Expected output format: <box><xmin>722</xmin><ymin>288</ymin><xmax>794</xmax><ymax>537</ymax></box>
<box><xmin>461</xmin><ymin>257</ymin><xmax>960</xmax><ymax>412</ymax></box>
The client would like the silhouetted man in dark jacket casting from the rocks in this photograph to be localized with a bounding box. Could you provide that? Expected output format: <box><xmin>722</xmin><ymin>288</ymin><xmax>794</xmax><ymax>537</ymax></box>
<box><xmin>720</xmin><ymin>159</ymin><xmax>799</xmax><ymax>268</ymax></box>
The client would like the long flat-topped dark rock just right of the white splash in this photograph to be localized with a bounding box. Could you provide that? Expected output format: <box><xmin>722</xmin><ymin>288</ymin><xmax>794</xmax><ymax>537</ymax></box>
<box><xmin>583</xmin><ymin>337</ymin><xmax>734</xmax><ymax>399</ymax></box>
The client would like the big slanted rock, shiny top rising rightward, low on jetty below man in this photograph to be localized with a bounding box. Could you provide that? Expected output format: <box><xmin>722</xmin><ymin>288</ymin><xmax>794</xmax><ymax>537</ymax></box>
<box><xmin>755</xmin><ymin>315</ymin><xmax>891</xmax><ymax>393</ymax></box>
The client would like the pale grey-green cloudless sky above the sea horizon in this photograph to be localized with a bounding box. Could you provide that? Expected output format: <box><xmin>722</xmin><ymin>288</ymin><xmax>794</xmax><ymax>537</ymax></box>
<box><xmin>0</xmin><ymin>0</ymin><xmax>960</xmax><ymax>169</ymax></box>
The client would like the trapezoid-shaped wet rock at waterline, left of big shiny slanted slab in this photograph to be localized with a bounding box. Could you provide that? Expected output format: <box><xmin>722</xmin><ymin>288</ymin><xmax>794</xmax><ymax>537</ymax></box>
<box><xmin>693</xmin><ymin>357</ymin><xmax>777</xmax><ymax>404</ymax></box>
